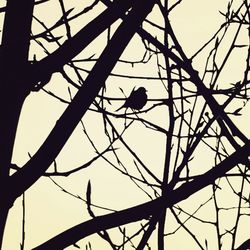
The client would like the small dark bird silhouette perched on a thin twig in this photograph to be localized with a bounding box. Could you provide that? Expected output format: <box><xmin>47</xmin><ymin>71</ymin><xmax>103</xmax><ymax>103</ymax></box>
<box><xmin>116</xmin><ymin>87</ymin><xmax>148</xmax><ymax>111</ymax></box>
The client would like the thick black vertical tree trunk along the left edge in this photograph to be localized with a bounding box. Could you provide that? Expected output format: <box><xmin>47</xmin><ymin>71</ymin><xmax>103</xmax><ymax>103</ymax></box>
<box><xmin>0</xmin><ymin>0</ymin><xmax>34</xmax><ymax>246</ymax></box>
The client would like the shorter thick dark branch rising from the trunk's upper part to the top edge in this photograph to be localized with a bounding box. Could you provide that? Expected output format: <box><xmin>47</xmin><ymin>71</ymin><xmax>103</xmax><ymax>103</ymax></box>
<box><xmin>29</xmin><ymin>0</ymin><xmax>132</xmax><ymax>88</ymax></box>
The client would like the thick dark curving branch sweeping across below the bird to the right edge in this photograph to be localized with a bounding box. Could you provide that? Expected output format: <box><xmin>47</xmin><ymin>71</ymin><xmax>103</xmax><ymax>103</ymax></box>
<box><xmin>34</xmin><ymin>141</ymin><xmax>250</xmax><ymax>250</ymax></box>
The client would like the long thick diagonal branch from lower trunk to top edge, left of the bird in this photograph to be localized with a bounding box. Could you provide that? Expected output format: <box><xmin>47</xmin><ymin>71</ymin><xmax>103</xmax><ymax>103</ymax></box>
<box><xmin>9</xmin><ymin>0</ymin><xmax>153</xmax><ymax>203</ymax></box>
